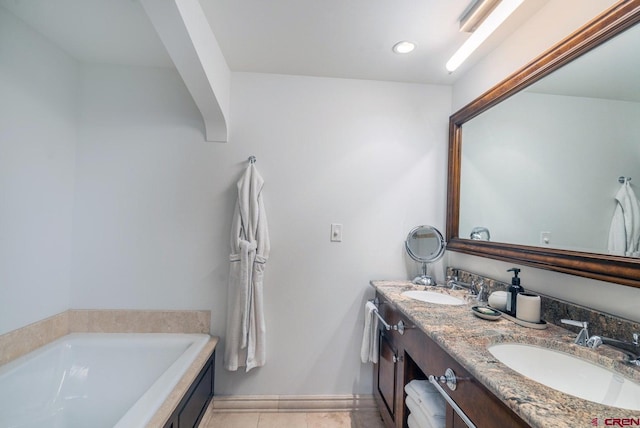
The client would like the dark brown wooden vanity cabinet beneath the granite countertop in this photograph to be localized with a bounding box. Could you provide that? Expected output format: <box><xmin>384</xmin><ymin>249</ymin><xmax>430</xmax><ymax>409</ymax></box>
<box><xmin>374</xmin><ymin>295</ymin><xmax>529</xmax><ymax>428</ymax></box>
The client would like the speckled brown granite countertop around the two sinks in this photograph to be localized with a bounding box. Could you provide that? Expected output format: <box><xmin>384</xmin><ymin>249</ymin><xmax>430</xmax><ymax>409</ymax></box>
<box><xmin>371</xmin><ymin>281</ymin><xmax>640</xmax><ymax>428</ymax></box>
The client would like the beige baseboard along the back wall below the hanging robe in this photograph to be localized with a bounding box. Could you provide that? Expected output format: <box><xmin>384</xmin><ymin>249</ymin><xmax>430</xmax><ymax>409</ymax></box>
<box><xmin>212</xmin><ymin>395</ymin><xmax>378</xmax><ymax>413</ymax></box>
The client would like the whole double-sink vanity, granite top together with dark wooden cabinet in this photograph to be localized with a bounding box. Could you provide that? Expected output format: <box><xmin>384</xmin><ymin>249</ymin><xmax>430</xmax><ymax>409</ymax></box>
<box><xmin>371</xmin><ymin>281</ymin><xmax>640</xmax><ymax>428</ymax></box>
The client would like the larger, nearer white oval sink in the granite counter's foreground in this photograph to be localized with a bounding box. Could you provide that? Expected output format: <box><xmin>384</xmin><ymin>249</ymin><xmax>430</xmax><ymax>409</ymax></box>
<box><xmin>488</xmin><ymin>343</ymin><xmax>640</xmax><ymax>410</ymax></box>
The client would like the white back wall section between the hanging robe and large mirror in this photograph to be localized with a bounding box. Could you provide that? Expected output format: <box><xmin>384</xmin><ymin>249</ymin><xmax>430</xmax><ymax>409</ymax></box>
<box><xmin>216</xmin><ymin>73</ymin><xmax>451</xmax><ymax>394</ymax></box>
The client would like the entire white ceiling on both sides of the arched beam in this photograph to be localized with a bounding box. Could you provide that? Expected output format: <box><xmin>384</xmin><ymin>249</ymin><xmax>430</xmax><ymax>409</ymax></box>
<box><xmin>0</xmin><ymin>0</ymin><xmax>548</xmax><ymax>84</ymax></box>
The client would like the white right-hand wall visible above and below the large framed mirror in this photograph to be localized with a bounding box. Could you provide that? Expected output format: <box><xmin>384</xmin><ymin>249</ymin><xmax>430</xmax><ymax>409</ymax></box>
<box><xmin>446</xmin><ymin>0</ymin><xmax>640</xmax><ymax>321</ymax></box>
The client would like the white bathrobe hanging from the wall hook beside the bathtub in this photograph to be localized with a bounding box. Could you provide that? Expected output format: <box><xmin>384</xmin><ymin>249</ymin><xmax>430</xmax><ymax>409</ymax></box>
<box><xmin>224</xmin><ymin>164</ymin><xmax>270</xmax><ymax>371</ymax></box>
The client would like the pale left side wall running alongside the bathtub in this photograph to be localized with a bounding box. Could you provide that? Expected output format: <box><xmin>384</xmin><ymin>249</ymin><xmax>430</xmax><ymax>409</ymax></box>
<box><xmin>0</xmin><ymin>7</ymin><xmax>78</xmax><ymax>334</ymax></box>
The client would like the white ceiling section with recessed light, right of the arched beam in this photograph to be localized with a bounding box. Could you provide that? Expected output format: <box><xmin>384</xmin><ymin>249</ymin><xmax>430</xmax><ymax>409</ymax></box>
<box><xmin>201</xmin><ymin>0</ymin><xmax>546</xmax><ymax>83</ymax></box>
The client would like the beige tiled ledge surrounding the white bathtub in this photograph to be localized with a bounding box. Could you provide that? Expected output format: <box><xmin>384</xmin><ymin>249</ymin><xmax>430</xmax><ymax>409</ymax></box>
<box><xmin>0</xmin><ymin>310</ymin><xmax>218</xmax><ymax>427</ymax></box>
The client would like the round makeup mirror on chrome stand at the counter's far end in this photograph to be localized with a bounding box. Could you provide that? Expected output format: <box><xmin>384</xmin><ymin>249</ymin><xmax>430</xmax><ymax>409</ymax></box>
<box><xmin>404</xmin><ymin>225</ymin><xmax>445</xmax><ymax>285</ymax></box>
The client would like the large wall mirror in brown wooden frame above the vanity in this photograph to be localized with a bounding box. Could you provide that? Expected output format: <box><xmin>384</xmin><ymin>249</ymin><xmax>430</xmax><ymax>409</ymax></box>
<box><xmin>447</xmin><ymin>0</ymin><xmax>640</xmax><ymax>287</ymax></box>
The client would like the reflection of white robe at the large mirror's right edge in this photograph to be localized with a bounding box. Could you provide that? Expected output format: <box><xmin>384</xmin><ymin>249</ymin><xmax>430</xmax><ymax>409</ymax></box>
<box><xmin>608</xmin><ymin>181</ymin><xmax>640</xmax><ymax>256</ymax></box>
